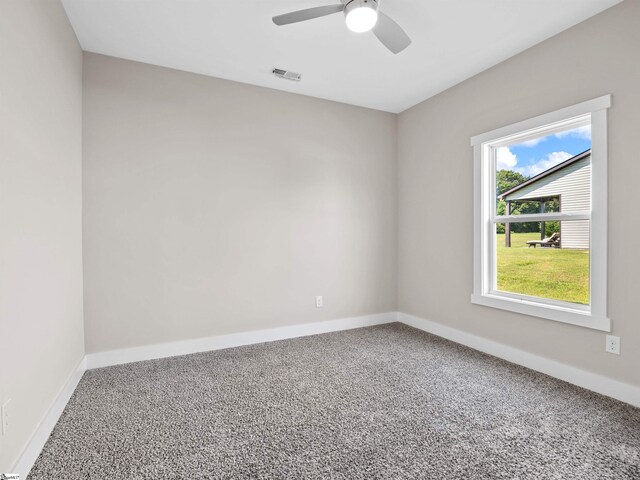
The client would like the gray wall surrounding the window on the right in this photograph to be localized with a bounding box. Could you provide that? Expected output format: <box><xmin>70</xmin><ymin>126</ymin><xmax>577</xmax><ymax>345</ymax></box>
<box><xmin>398</xmin><ymin>0</ymin><xmax>640</xmax><ymax>385</ymax></box>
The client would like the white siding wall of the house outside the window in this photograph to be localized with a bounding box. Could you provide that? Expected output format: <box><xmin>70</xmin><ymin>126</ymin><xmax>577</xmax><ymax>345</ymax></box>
<box><xmin>505</xmin><ymin>156</ymin><xmax>591</xmax><ymax>249</ymax></box>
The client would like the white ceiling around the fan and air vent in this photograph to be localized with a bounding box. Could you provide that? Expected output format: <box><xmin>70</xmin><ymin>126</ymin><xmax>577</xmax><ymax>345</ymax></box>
<box><xmin>63</xmin><ymin>0</ymin><xmax>621</xmax><ymax>113</ymax></box>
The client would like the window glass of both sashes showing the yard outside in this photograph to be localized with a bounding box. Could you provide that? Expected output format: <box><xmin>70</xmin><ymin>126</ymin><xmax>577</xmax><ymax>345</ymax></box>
<box><xmin>492</xmin><ymin>122</ymin><xmax>591</xmax><ymax>305</ymax></box>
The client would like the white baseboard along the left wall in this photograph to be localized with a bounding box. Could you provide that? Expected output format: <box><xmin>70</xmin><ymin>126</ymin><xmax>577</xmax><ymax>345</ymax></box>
<box><xmin>11</xmin><ymin>357</ymin><xmax>87</xmax><ymax>478</ymax></box>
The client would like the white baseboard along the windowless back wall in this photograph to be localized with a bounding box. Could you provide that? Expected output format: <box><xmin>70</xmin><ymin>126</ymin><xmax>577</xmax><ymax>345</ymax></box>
<box><xmin>86</xmin><ymin>312</ymin><xmax>397</xmax><ymax>369</ymax></box>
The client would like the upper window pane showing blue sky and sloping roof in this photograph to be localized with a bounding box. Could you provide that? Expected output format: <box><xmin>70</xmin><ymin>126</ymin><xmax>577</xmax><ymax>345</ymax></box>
<box><xmin>495</xmin><ymin>125</ymin><xmax>591</xmax><ymax>215</ymax></box>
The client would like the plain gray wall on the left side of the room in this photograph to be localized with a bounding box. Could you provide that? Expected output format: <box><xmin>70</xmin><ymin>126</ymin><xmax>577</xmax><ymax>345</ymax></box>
<box><xmin>0</xmin><ymin>0</ymin><xmax>84</xmax><ymax>472</ymax></box>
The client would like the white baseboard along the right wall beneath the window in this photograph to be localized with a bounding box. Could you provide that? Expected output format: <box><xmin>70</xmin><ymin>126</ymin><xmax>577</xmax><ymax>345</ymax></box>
<box><xmin>398</xmin><ymin>312</ymin><xmax>640</xmax><ymax>407</ymax></box>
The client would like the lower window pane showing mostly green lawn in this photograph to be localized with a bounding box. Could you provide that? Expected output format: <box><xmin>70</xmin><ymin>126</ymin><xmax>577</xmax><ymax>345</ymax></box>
<box><xmin>495</xmin><ymin>220</ymin><xmax>589</xmax><ymax>305</ymax></box>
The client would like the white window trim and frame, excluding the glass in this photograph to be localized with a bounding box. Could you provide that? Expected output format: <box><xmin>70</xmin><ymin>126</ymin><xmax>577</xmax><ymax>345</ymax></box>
<box><xmin>471</xmin><ymin>95</ymin><xmax>611</xmax><ymax>332</ymax></box>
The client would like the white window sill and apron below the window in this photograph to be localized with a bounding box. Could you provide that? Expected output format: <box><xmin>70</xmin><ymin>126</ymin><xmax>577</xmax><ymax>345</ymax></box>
<box><xmin>471</xmin><ymin>294</ymin><xmax>611</xmax><ymax>332</ymax></box>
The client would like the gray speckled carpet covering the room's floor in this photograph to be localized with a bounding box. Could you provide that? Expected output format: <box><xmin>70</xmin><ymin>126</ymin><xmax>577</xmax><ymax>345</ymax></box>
<box><xmin>29</xmin><ymin>324</ymin><xmax>640</xmax><ymax>480</ymax></box>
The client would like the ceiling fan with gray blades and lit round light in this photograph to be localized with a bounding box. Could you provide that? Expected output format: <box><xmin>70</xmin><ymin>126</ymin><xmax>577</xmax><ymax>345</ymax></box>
<box><xmin>272</xmin><ymin>0</ymin><xmax>411</xmax><ymax>53</ymax></box>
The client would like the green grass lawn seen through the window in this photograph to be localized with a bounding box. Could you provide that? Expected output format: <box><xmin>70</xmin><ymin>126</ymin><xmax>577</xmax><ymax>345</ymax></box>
<box><xmin>496</xmin><ymin>233</ymin><xmax>589</xmax><ymax>304</ymax></box>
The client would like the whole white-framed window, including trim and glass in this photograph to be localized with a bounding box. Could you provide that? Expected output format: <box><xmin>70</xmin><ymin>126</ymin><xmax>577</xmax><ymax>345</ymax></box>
<box><xmin>471</xmin><ymin>95</ymin><xmax>611</xmax><ymax>331</ymax></box>
